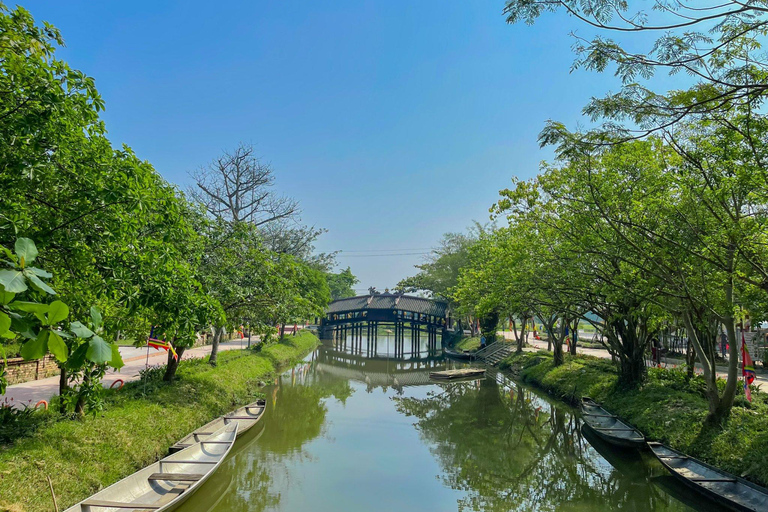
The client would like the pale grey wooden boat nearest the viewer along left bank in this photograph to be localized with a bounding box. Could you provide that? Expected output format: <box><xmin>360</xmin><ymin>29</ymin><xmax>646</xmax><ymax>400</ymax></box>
<box><xmin>65</xmin><ymin>423</ymin><xmax>237</xmax><ymax>512</ymax></box>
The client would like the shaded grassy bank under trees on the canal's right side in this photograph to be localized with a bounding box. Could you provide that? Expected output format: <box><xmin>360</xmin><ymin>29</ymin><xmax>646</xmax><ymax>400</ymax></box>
<box><xmin>500</xmin><ymin>351</ymin><xmax>768</xmax><ymax>485</ymax></box>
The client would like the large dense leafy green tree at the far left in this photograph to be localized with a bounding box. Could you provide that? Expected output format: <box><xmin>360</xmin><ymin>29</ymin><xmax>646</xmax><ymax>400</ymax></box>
<box><xmin>0</xmin><ymin>6</ymin><xmax>213</xmax><ymax>384</ymax></box>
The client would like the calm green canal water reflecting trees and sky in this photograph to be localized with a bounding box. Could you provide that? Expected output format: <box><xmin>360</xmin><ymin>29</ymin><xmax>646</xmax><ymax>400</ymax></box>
<box><xmin>179</xmin><ymin>338</ymin><xmax>728</xmax><ymax>512</ymax></box>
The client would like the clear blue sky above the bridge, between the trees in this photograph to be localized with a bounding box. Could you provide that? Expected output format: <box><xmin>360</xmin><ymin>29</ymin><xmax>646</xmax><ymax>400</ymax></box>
<box><xmin>23</xmin><ymin>0</ymin><xmax>617</xmax><ymax>289</ymax></box>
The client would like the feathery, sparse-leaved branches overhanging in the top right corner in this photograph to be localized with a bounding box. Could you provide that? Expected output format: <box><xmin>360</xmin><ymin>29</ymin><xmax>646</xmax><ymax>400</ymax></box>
<box><xmin>504</xmin><ymin>0</ymin><xmax>768</xmax><ymax>140</ymax></box>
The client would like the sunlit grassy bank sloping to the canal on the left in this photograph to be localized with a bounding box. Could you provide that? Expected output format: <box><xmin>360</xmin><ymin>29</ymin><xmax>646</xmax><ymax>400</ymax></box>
<box><xmin>0</xmin><ymin>332</ymin><xmax>318</xmax><ymax>512</ymax></box>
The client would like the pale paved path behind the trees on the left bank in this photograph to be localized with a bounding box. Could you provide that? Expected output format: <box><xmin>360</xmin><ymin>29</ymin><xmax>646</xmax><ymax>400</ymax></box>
<box><xmin>0</xmin><ymin>336</ymin><xmax>257</xmax><ymax>406</ymax></box>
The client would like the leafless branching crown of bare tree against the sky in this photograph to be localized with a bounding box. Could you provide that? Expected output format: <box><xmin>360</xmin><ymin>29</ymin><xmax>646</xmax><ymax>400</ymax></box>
<box><xmin>191</xmin><ymin>143</ymin><xmax>299</xmax><ymax>227</ymax></box>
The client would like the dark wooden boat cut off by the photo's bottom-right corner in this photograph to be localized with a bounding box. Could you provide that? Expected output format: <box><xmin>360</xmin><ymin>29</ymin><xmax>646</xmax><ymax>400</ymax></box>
<box><xmin>648</xmin><ymin>442</ymin><xmax>768</xmax><ymax>512</ymax></box>
